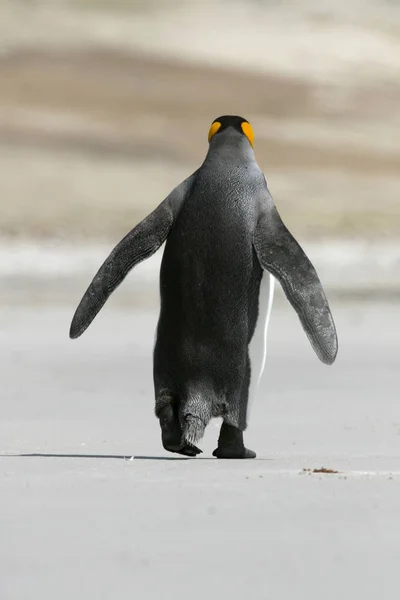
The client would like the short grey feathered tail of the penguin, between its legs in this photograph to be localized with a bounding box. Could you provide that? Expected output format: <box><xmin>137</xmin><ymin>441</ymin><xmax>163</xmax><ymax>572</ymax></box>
<box><xmin>180</xmin><ymin>390</ymin><xmax>226</xmax><ymax>445</ymax></box>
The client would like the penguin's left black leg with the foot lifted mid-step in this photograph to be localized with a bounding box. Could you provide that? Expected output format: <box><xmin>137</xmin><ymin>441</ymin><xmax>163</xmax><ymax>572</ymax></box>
<box><xmin>155</xmin><ymin>390</ymin><xmax>201</xmax><ymax>456</ymax></box>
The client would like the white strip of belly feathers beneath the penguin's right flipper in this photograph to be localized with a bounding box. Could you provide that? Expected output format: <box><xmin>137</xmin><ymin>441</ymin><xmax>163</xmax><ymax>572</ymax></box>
<box><xmin>247</xmin><ymin>271</ymin><xmax>275</xmax><ymax>422</ymax></box>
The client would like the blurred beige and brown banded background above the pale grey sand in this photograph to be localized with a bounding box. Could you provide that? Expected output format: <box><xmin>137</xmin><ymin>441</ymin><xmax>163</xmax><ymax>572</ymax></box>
<box><xmin>0</xmin><ymin>0</ymin><xmax>400</xmax><ymax>302</ymax></box>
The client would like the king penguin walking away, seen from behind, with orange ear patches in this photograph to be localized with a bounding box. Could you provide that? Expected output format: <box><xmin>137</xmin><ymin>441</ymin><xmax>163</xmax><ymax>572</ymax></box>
<box><xmin>70</xmin><ymin>115</ymin><xmax>338</xmax><ymax>458</ymax></box>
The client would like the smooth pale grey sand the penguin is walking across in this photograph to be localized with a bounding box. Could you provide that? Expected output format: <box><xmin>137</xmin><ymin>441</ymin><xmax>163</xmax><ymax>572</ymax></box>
<box><xmin>0</xmin><ymin>303</ymin><xmax>400</xmax><ymax>600</ymax></box>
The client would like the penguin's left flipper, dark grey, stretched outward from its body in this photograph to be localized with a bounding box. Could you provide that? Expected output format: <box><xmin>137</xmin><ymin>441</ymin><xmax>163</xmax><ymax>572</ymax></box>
<box><xmin>69</xmin><ymin>178</ymin><xmax>191</xmax><ymax>339</ymax></box>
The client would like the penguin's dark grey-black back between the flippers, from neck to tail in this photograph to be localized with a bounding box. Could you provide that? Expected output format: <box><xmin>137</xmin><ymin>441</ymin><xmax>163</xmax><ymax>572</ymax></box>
<box><xmin>154</xmin><ymin>165</ymin><xmax>262</xmax><ymax>422</ymax></box>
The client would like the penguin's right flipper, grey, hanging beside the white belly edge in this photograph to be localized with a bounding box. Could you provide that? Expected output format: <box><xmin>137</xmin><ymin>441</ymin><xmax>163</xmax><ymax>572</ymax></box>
<box><xmin>253</xmin><ymin>194</ymin><xmax>338</xmax><ymax>365</ymax></box>
